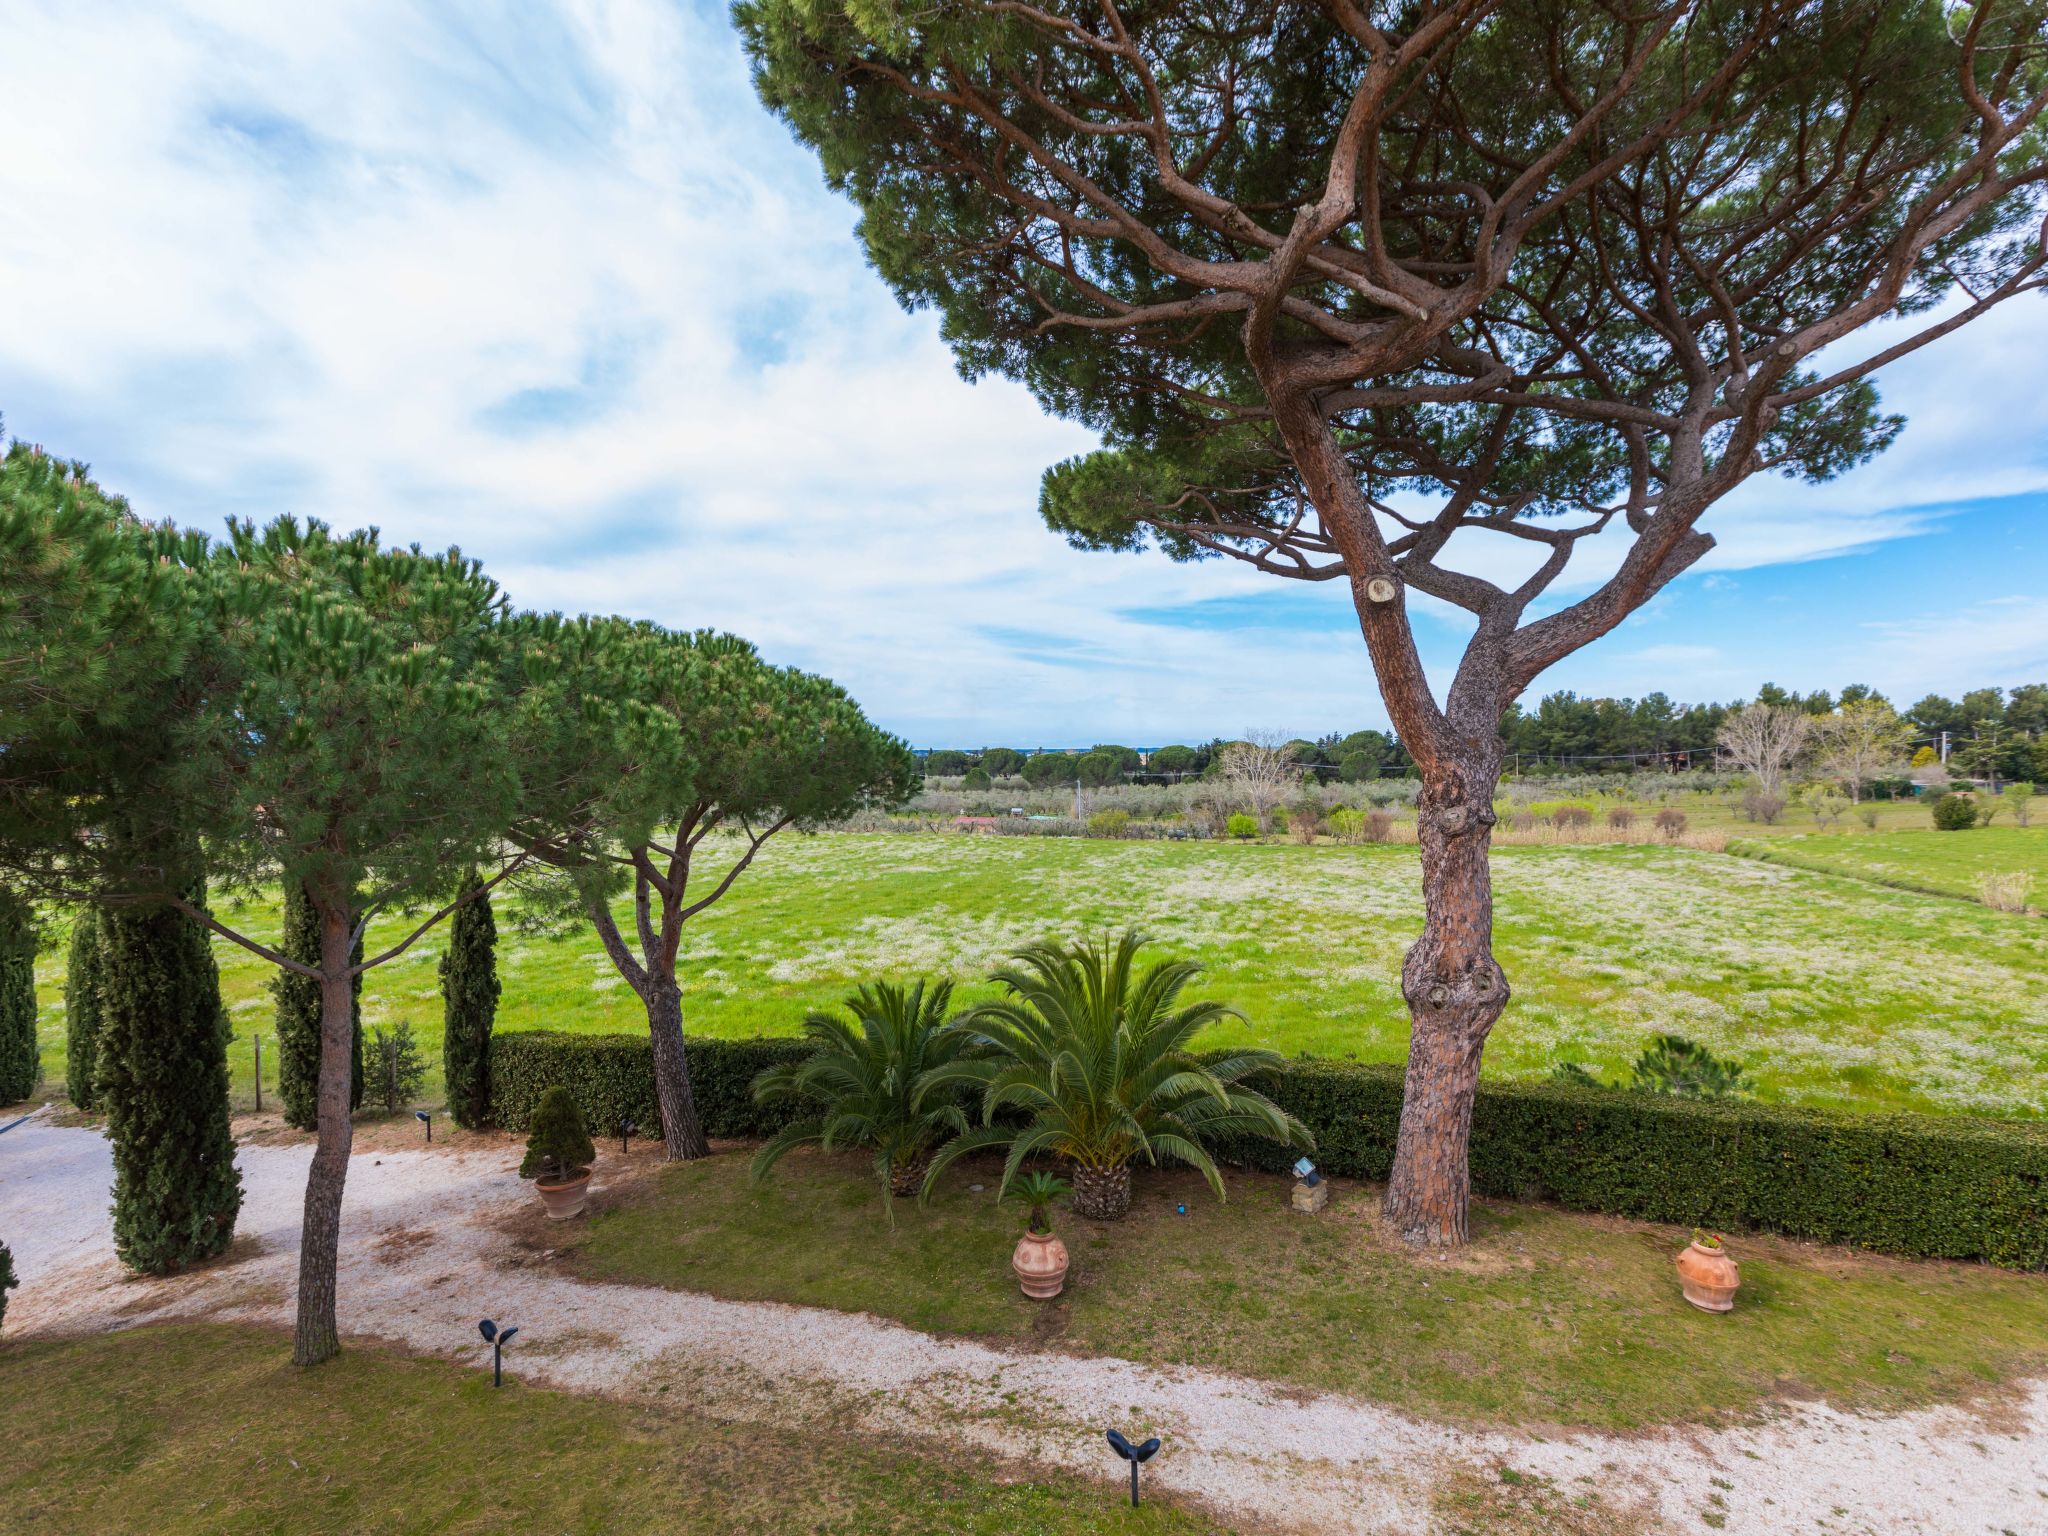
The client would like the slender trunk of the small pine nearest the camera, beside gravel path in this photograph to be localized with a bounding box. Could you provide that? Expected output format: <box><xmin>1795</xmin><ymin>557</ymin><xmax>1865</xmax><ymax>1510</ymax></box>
<box><xmin>291</xmin><ymin>905</ymin><xmax>358</xmax><ymax>1366</ymax></box>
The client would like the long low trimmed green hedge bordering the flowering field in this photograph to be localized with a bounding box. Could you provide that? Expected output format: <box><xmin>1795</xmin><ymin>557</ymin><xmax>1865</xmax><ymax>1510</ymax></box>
<box><xmin>492</xmin><ymin>1032</ymin><xmax>2048</xmax><ymax>1270</ymax></box>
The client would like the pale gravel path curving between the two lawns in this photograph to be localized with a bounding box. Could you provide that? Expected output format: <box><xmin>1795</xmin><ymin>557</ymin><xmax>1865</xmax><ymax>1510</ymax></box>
<box><xmin>0</xmin><ymin>1116</ymin><xmax>2048</xmax><ymax>1536</ymax></box>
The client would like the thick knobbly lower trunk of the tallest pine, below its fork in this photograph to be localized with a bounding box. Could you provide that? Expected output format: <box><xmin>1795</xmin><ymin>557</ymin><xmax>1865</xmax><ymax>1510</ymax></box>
<box><xmin>1386</xmin><ymin>750</ymin><xmax>1507</xmax><ymax>1247</ymax></box>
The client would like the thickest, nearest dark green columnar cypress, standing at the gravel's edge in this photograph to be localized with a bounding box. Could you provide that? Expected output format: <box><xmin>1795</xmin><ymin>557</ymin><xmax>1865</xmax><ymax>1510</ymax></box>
<box><xmin>94</xmin><ymin>887</ymin><xmax>242</xmax><ymax>1274</ymax></box>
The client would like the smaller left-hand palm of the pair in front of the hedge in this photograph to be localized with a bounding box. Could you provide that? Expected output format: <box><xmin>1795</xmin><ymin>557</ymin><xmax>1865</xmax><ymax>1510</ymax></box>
<box><xmin>754</xmin><ymin>979</ymin><xmax>975</xmax><ymax>1194</ymax></box>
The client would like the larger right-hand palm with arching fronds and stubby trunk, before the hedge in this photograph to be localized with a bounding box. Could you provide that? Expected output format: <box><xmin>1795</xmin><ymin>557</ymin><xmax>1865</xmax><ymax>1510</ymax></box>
<box><xmin>924</xmin><ymin>930</ymin><xmax>1311</xmax><ymax>1219</ymax></box>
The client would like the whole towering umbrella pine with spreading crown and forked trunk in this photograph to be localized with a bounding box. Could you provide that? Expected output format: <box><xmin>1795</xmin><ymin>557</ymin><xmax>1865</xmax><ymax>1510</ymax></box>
<box><xmin>749</xmin><ymin>0</ymin><xmax>2048</xmax><ymax>1243</ymax></box>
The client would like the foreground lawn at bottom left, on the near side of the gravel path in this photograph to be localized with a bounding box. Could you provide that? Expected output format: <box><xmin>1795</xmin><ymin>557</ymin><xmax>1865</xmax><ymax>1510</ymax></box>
<box><xmin>0</xmin><ymin>1325</ymin><xmax>1219</xmax><ymax>1536</ymax></box>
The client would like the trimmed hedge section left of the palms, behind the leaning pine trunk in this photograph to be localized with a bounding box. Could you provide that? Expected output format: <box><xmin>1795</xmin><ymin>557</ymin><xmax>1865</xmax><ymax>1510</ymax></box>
<box><xmin>489</xmin><ymin>1030</ymin><xmax>811</xmax><ymax>1139</ymax></box>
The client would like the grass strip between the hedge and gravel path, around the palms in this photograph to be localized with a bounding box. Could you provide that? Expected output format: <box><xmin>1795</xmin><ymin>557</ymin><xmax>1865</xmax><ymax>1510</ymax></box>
<box><xmin>549</xmin><ymin>1153</ymin><xmax>2048</xmax><ymax>1430</ymax></box>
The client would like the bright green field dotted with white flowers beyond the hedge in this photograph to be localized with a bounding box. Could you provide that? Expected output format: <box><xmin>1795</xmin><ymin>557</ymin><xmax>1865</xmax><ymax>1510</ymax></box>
<box><xmin>39</xmin><ymin>825</ymin><xmax>2048</xmax><ymax>1114</ymax></box>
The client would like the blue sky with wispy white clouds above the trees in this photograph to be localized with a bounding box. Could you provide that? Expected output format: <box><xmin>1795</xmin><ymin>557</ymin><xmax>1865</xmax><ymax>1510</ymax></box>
<box><xmin>0</xmin><ymin>0</ymin><xmax>2048</xmax><ymax>745</ymax></box>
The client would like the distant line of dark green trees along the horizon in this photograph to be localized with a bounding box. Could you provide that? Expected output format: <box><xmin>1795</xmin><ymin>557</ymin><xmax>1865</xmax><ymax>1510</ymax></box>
<box><xmin>924</xmin><ymin>682</ymin><xmax>2048</xmax><ymax>786</ymax></box>
